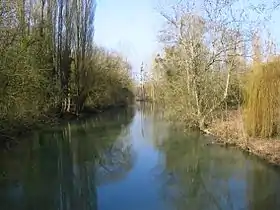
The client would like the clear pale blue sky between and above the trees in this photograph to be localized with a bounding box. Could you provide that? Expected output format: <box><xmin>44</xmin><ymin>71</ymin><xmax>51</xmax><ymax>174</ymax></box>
<box><xmin>95</xmin><ymin>0</ymin><xmax>280</xmax><ymax>79</ymax></box>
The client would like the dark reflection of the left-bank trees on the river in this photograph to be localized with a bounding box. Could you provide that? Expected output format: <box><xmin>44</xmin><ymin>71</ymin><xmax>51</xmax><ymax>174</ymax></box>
<box><xmin>0</xmin><ymin>109</ymin><xmax>134</xmax><ymax>210</ymax></box>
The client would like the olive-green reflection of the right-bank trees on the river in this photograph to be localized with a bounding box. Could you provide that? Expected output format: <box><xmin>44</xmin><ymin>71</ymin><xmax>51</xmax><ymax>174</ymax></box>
<box><xmin>142</xmin><ymin>104</ymin><xmax>280</xmax><ymax>210</ymax></box>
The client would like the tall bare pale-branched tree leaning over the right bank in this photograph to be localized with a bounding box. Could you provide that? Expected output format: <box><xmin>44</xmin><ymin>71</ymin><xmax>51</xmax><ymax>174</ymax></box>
<box><xmin>153</xmin><ymin>0</ymin><xmax>252</xmax><ymax>132</ymax></box>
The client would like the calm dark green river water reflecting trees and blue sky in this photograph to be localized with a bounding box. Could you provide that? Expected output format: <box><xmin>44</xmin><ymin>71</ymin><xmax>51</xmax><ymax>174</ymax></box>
<box><xmin>0</xmin><ymin>107</ymin><xmax>280</xmax><ymax>210</ymax></box>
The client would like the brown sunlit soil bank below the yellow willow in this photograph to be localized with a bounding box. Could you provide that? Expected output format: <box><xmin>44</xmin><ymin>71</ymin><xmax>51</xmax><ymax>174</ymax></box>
<box><xmin>209</xmin><ymin>111</ymin><xmax>280</xmax><ymax>166</ymax></box>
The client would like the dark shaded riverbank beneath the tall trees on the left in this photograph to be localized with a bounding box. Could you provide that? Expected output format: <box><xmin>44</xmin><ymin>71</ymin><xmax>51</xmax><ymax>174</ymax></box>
<box><xmin>0</xmin><ymin>104</ymin><xmax>128</xmax><ymax>149</ymax></box>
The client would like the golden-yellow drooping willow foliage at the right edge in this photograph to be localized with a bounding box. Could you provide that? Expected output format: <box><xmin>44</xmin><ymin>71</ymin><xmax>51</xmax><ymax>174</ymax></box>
<box><xmin>244</xmin><ymin>58</ymin><xmax>280</xmax><ymax>137</ymax></box>
